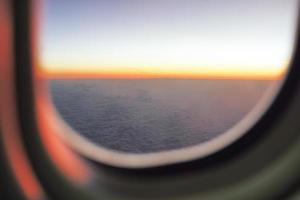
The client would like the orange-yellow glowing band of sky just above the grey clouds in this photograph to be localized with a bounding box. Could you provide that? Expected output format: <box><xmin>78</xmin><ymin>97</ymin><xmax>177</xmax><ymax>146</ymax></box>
<box><xmin>38</xmin><ymin>63</ymin><xmax>287</xmax><ymax>80</ymax></box>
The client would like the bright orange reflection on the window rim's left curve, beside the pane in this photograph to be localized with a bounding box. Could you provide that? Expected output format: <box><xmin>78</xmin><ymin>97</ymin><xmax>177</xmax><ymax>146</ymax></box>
<box><xmin>31</xmin><ymin>0</ymin><xmax>92</xmax><ymax>184</ymax></box>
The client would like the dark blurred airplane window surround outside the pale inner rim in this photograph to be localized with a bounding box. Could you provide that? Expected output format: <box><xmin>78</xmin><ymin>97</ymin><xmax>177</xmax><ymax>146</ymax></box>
<box><xmin>0</xmin><ymin>0</ymin><xmax>300</xmax><ymax>200</ymax></box>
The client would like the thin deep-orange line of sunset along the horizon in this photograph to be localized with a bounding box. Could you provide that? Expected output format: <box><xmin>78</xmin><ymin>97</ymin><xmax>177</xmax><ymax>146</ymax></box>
<box><xmin>35</xmin><ymin>68</ymin><xmax>286</xmax><ymax>80</ymax></box>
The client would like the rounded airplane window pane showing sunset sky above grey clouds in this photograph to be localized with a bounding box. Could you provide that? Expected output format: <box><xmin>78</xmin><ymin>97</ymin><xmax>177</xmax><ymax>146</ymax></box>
<box><xmin>38</xmin><ymin>0</ymin><xmax>297</xmax><ymax>166</ymax></box>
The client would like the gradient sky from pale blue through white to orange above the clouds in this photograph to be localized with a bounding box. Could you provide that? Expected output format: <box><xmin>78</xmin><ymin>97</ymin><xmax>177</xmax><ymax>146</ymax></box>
<box><xmin>40</xmin><ymin>0</ymin><xmax>297</xmax><ymax>78</ymax></box>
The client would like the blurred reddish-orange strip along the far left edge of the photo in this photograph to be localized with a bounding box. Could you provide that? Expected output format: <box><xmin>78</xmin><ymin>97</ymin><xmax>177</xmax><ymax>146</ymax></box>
<box><xmin>0</xmin><ymin>0</ymin><xmax>45</xmax><ymax>200</ymax></box>
